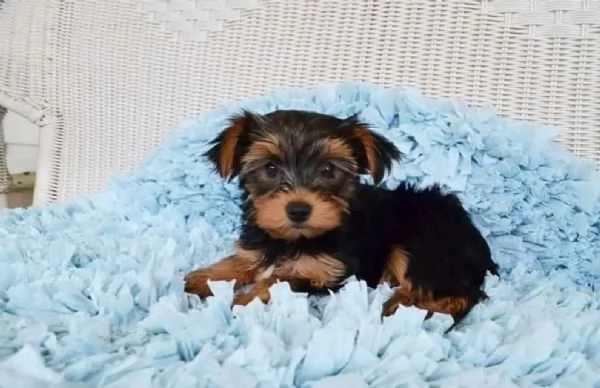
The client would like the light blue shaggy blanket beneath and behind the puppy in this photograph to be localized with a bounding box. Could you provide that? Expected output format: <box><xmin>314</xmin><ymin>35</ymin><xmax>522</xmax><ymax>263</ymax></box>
<box><xmin>0</xmin><ymin>83</ymin><xmax>600</xmax><ymax>388</ymax></box>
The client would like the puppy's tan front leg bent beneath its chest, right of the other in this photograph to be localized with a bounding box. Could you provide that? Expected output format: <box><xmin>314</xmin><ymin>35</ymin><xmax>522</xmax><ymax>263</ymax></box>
<box><xmin>233</xmin><ymin>255</ymin><xmax>346</xmax><ymax>304</ymax></box>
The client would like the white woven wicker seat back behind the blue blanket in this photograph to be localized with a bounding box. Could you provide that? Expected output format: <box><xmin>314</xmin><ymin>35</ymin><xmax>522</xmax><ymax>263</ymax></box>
<box><xmin>0</xmin><ymin>0</ymin><xmax>600</xmax><ymax>204</ymax></box>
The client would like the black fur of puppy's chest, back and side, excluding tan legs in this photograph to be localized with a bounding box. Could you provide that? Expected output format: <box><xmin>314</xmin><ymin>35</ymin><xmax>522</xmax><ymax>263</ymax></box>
<box><xmin>240</xmin><ymin>183</ymin><xmax>498</xmax><ymax>305</ymax></box>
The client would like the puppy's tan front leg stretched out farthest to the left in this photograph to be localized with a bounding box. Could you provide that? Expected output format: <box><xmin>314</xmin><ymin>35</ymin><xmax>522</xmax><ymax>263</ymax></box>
<box><xmin>184</xmin><ymin>248</ymin><xmax>263</xmax><ymax>297</ymax></box>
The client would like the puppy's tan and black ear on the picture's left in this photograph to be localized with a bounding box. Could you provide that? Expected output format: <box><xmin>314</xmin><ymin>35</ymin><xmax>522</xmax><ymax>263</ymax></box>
<box><xmin>204</xmin><ymin>111</ymin><xmax>259</xmax><ymax>178</ymax></box>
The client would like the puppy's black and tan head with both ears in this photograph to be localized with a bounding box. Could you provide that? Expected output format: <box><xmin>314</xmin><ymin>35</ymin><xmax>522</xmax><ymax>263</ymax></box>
<box><xmin>205</xmin><ymin>110</ymin><xmax>400</xmax><ymax>240</ymax></box>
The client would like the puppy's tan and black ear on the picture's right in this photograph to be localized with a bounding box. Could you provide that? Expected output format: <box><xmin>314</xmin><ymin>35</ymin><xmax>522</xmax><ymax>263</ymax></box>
<box><xmin>342</xmin><ymin>116</ymin><xmax>402</xmax><ymax>184</ymax></box>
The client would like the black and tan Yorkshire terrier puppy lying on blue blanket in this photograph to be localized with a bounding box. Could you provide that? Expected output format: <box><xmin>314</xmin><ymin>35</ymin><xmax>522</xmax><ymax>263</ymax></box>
<box><xmin>185</xmin><ymin>110</ymin><xmax>497</xmax><ymax>330</ymax></box>
